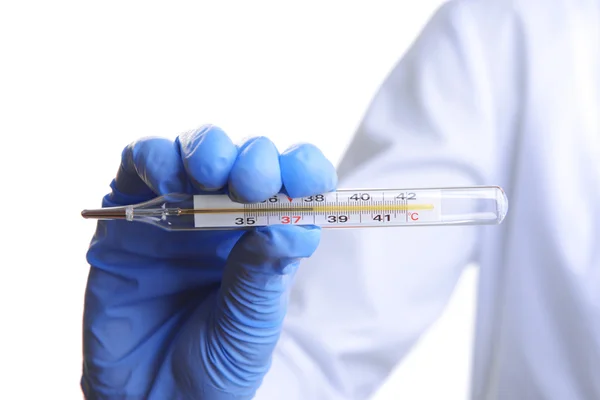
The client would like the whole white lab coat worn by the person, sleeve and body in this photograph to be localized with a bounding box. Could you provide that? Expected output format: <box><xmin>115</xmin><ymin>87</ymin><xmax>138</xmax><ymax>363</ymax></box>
<box><xmin>257</xmin><ymin>0</ymin><xmax>600</xmax><ymax>400</ymax></box>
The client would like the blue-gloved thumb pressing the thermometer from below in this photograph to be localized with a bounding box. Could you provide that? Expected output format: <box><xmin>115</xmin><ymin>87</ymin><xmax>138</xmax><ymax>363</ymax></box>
<box><xmin>171</xmin><ymin>225</ymin><xmax>321</xmax><ymax>400</ymax></box>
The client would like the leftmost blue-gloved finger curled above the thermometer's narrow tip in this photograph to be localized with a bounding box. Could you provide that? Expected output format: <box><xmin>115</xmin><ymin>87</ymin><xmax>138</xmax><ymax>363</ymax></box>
<box><xmin>113</xmin><ymin>137</ymin><xmax>190</xmax><ymax>202</ymax></box>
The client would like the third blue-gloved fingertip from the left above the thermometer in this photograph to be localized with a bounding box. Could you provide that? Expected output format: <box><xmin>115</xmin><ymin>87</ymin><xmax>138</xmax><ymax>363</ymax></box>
<box><xmin>229</xmin><ymin>137</ymin><xmax>281</xmax><ymax>203</ymax></box>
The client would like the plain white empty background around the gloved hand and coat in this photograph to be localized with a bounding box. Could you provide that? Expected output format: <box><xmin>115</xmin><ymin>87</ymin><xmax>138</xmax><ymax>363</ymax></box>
<box><xmin>0</xmin><ymin>0</ymin><xmax>476</xmax><ymax>400</ymax></box>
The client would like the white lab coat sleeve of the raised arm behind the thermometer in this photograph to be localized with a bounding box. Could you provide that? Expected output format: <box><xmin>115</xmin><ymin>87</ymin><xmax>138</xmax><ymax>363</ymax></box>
<box><xmin>256</xmin><ymin>2</ymin><xmax>508</xmax><ymax>400</ymax></box>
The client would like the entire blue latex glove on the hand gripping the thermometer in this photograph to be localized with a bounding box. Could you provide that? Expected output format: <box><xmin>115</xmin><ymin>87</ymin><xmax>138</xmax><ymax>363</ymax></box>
<box><xmin>81</xmin><ymin>126</ymin><xmax>337</xmax><ymax>400</ymax></box>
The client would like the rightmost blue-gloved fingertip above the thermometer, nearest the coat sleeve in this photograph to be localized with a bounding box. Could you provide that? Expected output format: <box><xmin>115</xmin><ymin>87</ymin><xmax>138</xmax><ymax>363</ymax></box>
<box><xmin>279</xmin><ymin>144</ymin><xmax>338</xmax><ymax>198</ymax></box>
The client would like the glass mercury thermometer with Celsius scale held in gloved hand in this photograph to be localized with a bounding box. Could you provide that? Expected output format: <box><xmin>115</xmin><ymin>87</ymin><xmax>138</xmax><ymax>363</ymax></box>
<box><xmin>81</xmin><ymin>186</ymin><xmax>508</xmax><ymax>231</ymax></box>
